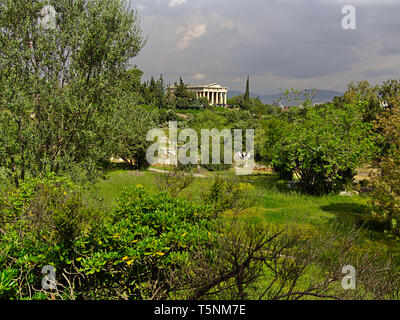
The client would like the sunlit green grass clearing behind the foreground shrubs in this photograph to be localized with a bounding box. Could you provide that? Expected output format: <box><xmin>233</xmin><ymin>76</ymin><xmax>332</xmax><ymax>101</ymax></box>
<box><xmin>96</xmin><ymin>170</ymin><xmax>400</xmax><ymax>256</ymax></box>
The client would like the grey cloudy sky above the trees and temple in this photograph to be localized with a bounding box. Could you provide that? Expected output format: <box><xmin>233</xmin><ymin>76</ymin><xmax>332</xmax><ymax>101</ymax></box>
<box><xmin>132</xmin><ymin>0</ymin><xmax>400</xmax><ymax>94</ymax></box>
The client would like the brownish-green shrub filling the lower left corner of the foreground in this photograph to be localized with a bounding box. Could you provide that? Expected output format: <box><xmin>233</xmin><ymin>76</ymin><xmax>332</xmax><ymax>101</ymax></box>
<box><xmin>0</xmin><ymin>174</ymin><xmax>103</xmax><ymax>299</ymax></box>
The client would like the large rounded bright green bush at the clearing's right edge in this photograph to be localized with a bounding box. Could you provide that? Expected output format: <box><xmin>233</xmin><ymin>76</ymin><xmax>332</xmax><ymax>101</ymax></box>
<box><xmin>258</xmin><ymin>104</ymin><xmax>374</xmax><ymax>194</ymax></box>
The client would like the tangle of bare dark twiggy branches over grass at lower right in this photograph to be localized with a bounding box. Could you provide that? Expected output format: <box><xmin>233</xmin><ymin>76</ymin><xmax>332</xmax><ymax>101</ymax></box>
<box><xmin>171</xmin><ymin>220</ymin><xmax>399</xmax><ymax>300</ymax></box>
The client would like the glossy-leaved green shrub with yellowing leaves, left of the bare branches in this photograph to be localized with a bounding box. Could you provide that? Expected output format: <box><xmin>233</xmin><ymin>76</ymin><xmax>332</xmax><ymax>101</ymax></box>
<box><xmin>79</xmin><ymin>187</ymin><xmax>219</xmax><ymax>299</ymax></box>
